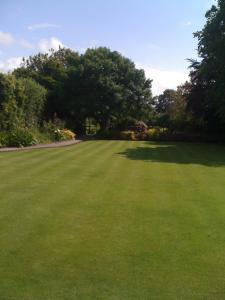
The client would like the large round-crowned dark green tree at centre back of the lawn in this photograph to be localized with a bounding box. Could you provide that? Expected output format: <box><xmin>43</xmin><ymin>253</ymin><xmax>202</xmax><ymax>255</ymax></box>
<box><xmin>77</xmin><ymin>48</ymin><xmax>152</xmax><ymax>129</ymax></box>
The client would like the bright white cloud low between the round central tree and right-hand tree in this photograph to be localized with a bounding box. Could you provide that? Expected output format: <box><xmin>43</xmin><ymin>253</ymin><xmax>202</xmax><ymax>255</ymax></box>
<box><xmin>137</xmin><ymin>64</ymin><xmax>188</xmax><ymax>95</ymax></box>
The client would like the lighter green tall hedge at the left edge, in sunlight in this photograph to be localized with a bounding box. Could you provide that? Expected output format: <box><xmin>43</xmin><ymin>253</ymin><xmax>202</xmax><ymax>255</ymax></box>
<box><xmin>0</xmin><ymin>74</ymin><xmax>46</xmax><ymax>130</ymax></box>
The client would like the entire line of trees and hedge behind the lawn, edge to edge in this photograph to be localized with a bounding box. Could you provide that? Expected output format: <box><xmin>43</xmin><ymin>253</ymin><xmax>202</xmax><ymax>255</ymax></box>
<box><xmin>0</xmin><ymin>0</ymin><xmax>225</xmax><ymax>144</ymax></box>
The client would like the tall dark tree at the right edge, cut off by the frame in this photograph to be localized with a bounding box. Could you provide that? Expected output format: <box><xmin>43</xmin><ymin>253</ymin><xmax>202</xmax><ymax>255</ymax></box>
<box><xmin>188</xmin><ymin>0</ymin><xmax>225</xmax><ymax>132</ymax></box>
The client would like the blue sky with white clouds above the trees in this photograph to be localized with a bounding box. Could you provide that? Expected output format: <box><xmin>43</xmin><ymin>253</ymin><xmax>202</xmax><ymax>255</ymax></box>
<box><xmin>0</xmin><ymin>0</ymin><xmax>216</xmax><ymax>95</ymax></box>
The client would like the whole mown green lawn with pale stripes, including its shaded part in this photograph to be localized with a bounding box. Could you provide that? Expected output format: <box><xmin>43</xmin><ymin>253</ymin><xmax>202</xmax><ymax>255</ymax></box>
<box><xmin>0</xmin><ymin>141</ymin><xmax>225</xmax><ymax>300</ymax></box>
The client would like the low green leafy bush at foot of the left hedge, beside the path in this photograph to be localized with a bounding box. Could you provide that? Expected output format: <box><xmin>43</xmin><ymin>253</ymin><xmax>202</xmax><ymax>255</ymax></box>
<box><xmin>6</xmin><ymin>129</ymin><xmax>38</xmax><ymax>147</ymax></box>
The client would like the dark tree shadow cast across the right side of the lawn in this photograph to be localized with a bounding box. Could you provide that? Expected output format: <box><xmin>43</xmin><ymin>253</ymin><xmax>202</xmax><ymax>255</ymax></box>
<box><xmin>117</xmin><ymin>142</ymin><xmax>225</xmax><ymax>167</ymax></box>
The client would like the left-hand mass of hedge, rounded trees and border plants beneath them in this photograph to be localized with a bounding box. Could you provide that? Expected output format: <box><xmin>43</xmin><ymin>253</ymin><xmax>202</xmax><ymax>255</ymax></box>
<box><xmin>0</xmin><ymin>48</ymin><xmax>153</xmax><ymax>146</ymax></box>
